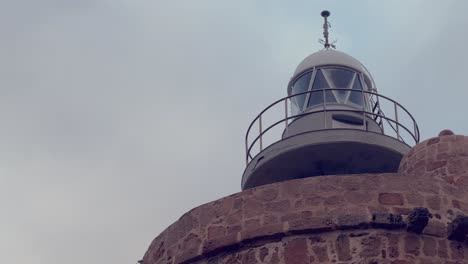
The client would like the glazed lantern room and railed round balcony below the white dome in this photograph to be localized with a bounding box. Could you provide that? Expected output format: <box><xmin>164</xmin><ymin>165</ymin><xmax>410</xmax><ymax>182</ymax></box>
<box><xmin>242</xmin><ymin>65</ymin><xmax>419</xmax><ymax>189</ymax></box>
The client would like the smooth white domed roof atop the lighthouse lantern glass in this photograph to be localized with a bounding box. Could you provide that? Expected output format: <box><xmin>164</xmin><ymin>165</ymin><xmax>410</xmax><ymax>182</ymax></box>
<box><xmin>294</xmin><ymin>49</ymin><xmax>372</xmax><ymax>79</ymax></box>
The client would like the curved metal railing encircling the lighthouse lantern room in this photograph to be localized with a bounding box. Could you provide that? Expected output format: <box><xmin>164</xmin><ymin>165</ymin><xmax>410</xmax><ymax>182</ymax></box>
<box><xmin>245</xmin><ymin>88</ymin><xmax>419</xmax><ymax>164</ymax></box>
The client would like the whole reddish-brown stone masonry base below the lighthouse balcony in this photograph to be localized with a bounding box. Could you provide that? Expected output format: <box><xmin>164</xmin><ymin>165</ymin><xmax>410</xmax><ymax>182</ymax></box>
<box><xmin>143</xmin><ymin>135</ymin><xmax>468</xmax><ymax>264</ymax></box>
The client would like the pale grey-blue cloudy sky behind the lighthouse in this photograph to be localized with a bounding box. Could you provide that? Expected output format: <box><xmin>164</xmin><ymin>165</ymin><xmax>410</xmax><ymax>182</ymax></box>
<box><xmin>0</xmin><ymin>0</ymin><xmax>468</xmax><ymax>264</ymax></box>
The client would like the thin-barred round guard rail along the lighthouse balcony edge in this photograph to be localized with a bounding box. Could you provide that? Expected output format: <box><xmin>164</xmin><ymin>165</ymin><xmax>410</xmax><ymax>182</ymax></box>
<box><xmin>245</xmin><ymin>88</ymin><xmax>420</xmax><ymax>163</ymax></box>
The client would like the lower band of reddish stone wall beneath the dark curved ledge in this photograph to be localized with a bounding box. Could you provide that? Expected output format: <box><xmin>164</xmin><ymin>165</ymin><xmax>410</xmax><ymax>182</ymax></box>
<box><xmin>194</xmin><ymin>230</ymin><xmax>468</xmax><ymax>264</ymax></box>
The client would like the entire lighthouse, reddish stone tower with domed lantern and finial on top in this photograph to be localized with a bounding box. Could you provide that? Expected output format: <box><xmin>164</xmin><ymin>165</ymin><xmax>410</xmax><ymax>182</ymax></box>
<box><xmin>140</xmin><ymin>11</ymin><xmax>468</xmax><ymax>264</ymax></box>
